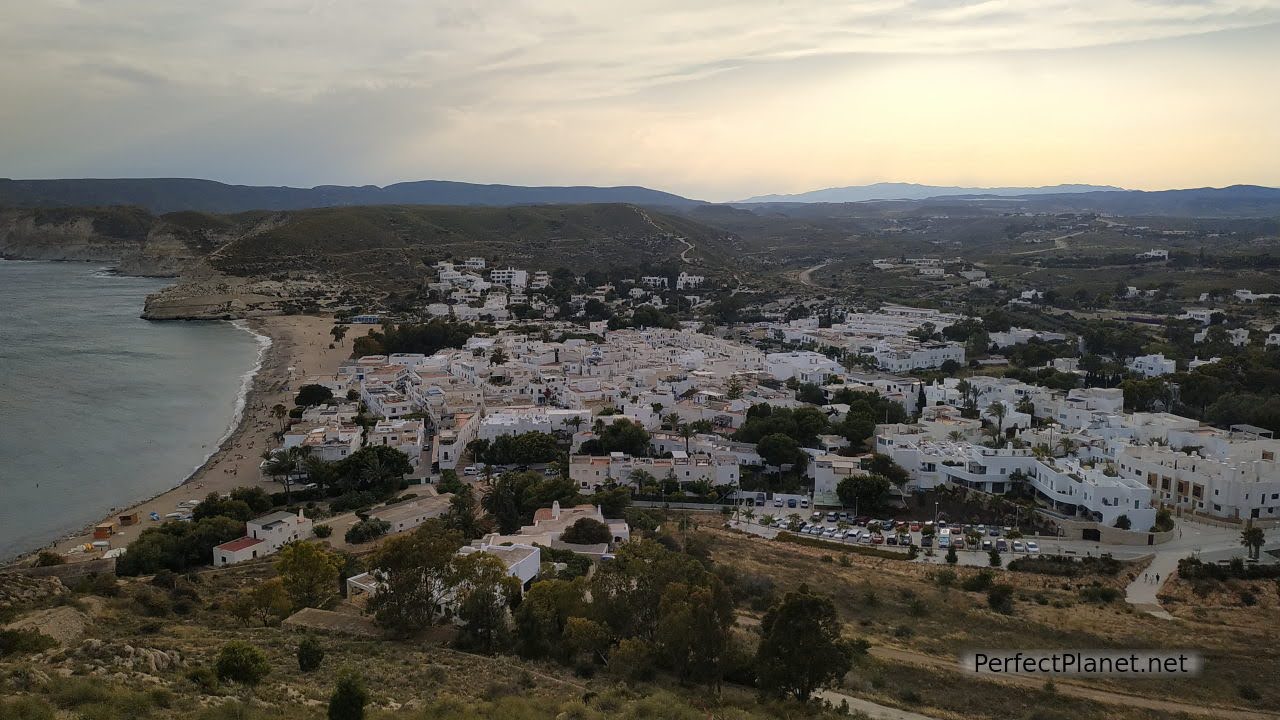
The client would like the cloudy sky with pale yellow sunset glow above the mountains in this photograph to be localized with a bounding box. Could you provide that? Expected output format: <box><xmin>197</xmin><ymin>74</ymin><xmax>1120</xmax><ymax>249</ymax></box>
<box><xmin>0</xmin><ymin>0</ymin><xmax>1280</xmax><ymax>201</ymax></box>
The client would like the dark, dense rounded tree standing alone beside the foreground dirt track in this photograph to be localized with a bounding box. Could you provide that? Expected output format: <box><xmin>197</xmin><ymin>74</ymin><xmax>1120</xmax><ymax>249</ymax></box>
<box><xmin>755</xmin><ymin>585</ymin><xmax>855</xmax><ymax>702</ymax></box>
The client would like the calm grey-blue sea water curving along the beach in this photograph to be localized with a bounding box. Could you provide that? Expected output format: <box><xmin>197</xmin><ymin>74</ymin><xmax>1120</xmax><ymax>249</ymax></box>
<box><xmin>0</xmin><ymin>260</ymin><xmax>261</xmax><ymax>557</ymax></box>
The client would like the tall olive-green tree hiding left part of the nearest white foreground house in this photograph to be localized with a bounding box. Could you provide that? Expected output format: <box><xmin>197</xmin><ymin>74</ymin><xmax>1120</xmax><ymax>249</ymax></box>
<box><xmin>369</xmin><ymin>520</ymin><xmax>462</xmax><ymax>637</ymax></box>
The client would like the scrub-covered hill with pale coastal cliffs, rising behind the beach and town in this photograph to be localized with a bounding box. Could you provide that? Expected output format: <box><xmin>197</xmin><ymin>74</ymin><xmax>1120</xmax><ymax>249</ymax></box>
<box><xmin>0</xmin><ymin>204</ymin><xmax>741</xmax><ymax>319</ymax></box>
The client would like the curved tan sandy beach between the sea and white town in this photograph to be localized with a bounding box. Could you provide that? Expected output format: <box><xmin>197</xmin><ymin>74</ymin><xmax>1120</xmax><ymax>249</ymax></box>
<box><xmin>35</xmin><ymin>315</ymin><xmax>355</xmax><ymax>560</ymax></box>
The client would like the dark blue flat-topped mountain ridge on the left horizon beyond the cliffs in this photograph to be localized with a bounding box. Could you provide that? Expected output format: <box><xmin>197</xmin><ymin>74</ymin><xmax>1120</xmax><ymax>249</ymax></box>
<box><xmin>0</xmin><ymin>178</ymin><xmax>703</xmax><ymax>213</ymax></box>
